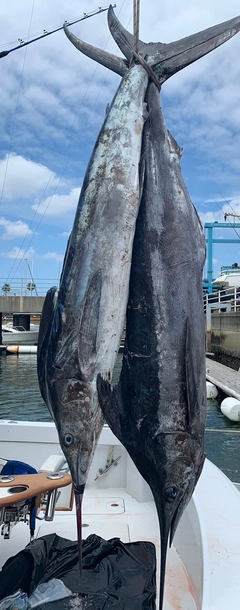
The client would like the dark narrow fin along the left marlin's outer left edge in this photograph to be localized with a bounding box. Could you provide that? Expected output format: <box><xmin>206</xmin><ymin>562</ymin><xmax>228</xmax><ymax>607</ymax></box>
<box><xmin>37</xmin><ymin>286</ymin><xmax>56</xmax><ymax>402</ymax></box>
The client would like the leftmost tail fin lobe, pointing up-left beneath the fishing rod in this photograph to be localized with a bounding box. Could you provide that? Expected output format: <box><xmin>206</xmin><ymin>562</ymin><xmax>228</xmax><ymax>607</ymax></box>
<box><xmin>63</xmin><ymin>24</ymin><xmax>128</xmax><ymax>76</ymax></box>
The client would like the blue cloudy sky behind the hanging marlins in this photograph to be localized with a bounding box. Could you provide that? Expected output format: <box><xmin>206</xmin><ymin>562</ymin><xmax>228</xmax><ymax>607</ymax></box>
<box><xmin>0</xmin><ymin>0</ymin><xmax>240</xmax><ymax>292</ymax></box>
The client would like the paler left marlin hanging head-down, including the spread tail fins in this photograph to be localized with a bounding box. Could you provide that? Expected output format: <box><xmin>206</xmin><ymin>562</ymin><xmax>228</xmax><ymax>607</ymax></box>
<box><xmin>38</xmin><ymin>2</ymin><xmax>240</xmax><ymax>576</ymax></box>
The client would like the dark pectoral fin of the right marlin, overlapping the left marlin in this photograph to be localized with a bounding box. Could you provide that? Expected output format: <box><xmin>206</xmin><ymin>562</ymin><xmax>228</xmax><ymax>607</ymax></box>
<box><xmin>97</xmin><ymin>373</ymin><xmax>122</xmax><ymax>443</ymax></box>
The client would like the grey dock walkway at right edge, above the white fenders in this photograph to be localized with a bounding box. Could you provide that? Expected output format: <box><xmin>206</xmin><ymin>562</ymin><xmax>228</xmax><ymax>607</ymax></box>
<box><xmin>206</xmin><ymin>358</ymin><xmax>240</xmax><ymax>400</ymax></box>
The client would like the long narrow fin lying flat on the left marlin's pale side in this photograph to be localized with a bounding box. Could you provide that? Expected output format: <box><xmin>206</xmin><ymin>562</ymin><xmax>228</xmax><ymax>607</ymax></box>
<box><xmin>78</xmin><ymin>269</ymin><xmax>102</xmax><ymax>381</ymax></box>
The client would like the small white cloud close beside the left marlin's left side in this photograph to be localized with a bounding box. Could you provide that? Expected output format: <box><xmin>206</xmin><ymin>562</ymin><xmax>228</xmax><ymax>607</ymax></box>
<box><xmin>32</xmin><ymin>188</ymin><xmax>80</xmax><ymax>216</ymax></box>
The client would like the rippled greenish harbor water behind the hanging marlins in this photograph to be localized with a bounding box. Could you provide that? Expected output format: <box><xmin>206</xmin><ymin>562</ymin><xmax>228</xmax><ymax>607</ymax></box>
<box><xmin>0</xmin><ymin>354</ymin><xmax>240</xmax><ymax>483</ymax></box>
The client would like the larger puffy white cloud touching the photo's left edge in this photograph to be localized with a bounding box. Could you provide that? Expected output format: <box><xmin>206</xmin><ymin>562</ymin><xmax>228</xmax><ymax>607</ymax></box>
<box><xmin>0</xmin><ymin>153</ymin><xmax>58</xmax><ymax>199</ymax></box>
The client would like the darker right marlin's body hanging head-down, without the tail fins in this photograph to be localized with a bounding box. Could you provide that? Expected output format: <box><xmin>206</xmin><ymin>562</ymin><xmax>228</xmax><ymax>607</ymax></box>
<box><xmin>98</xmin><ymin>84</ymin><xmax>206</xmax><ymax>609</ymax></box>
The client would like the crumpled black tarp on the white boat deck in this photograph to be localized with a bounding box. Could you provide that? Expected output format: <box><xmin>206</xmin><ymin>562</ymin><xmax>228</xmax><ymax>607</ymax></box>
<box><xmin>0</xmin><ymin>534</ymin><xmax>156</xmax><ymax>610</ymax></box>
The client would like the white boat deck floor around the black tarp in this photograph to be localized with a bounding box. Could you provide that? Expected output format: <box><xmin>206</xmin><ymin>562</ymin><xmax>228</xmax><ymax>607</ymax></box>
<box><xmin>0</xmin><ymin>488</ymin><xmax>197</xmax><ymax>610</ymax></box>
